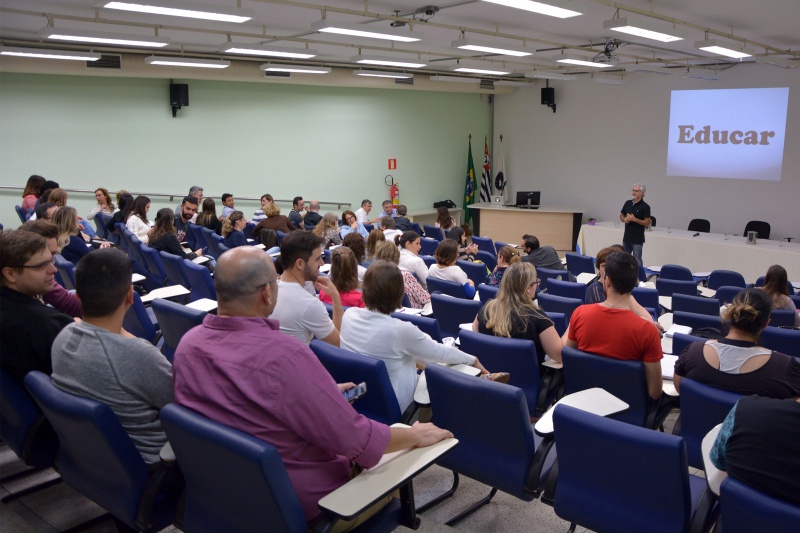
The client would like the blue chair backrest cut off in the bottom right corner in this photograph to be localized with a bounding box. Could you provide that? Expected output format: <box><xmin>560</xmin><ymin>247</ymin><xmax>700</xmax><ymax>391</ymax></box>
<box><xmin>720</xmin><ymin>477</ymin><xmax>800</xmax><ymax>533</ymax></box>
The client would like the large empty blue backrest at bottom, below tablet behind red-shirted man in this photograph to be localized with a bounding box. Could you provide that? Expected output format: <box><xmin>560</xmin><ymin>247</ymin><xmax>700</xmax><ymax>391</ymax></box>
<box><xmin>553</xmin><ymin>404</ymin><xmax>692</xmax><ymax>533</ymax></box>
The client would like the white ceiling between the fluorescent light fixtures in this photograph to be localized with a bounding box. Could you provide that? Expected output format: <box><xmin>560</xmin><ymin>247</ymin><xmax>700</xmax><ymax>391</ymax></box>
<box><xmin>0</xmin><ymin>0</ymin><xmax>800</xmax><ymax>79</ymax></box>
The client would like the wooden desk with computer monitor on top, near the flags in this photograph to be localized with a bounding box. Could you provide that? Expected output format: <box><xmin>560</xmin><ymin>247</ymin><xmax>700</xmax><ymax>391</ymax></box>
<box><xmin>469</xmin><ymin>203</ymin><xmax>583</xmax><ymax>251</ymax></box>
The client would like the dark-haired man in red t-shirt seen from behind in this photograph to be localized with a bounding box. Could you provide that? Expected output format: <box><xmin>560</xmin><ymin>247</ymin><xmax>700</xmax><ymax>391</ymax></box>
<box><xmin>564</xmin><ymin>252</ymin><xmax>664</xmax><ymax>399</ymax></box>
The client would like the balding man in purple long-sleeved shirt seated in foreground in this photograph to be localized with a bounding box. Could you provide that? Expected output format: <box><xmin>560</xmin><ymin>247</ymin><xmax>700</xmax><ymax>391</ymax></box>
<box><xmin>173</xmin><ymin>247</ymin><xmax>452</xmax><ymax>529</ymax></box>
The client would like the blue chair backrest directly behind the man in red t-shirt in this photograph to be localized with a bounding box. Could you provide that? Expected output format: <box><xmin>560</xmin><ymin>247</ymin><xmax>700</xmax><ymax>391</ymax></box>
<box><xmin>561</xmin><ymin>346</ymin><xmax>650</xmax><ymax>426</ymax></box>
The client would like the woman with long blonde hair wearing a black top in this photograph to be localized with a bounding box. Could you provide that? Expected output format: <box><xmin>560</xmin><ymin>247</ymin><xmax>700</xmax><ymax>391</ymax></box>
<box><xmin>472</xmin><ymin>261</ymin><xmax>561</xmax><ymax>365</ymax></box>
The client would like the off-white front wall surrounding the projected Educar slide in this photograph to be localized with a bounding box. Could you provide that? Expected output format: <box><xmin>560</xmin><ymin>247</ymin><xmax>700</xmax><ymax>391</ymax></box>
<box><xmin>494</xmin><ymin>63</ymin><xmax>800</xmax><ymax>239</ymax></box>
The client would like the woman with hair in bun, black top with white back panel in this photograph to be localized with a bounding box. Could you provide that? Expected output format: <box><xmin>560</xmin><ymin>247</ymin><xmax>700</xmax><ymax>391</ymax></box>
<box><xmin>674</xmin><ymin>289</ymin><xmax>800</xmax><ymax>398</ymax></box>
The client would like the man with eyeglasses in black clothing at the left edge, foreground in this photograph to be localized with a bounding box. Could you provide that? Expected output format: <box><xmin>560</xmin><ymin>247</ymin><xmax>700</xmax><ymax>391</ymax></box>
<box><xmin>0</xmin><ymin>230</ymin><xmax>73</xmax><ymax>384</ymax></box>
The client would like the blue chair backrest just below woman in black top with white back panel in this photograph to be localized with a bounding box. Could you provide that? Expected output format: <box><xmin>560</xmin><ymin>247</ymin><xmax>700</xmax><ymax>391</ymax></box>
<box><xmin>680</xmin><ymin>379</ymin><xmax>742</xmax><ymax>470</ymax></box>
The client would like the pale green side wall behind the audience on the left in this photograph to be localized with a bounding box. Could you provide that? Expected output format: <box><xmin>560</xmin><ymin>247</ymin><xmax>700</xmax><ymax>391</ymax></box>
<box><xmin>0</xmin><ymin>73</ymin><xmax>491</xmax><ymax>227</ymax></box>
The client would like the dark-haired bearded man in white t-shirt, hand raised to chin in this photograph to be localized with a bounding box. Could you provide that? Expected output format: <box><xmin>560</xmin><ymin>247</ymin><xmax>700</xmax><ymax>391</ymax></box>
<box><xmin>272</xmin><ymin>231</ymin><xmax>344</xmax><ymax>346</ymax></box>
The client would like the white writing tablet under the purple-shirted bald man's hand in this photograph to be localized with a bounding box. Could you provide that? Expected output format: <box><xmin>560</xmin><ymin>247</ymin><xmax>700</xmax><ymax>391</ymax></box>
<box><xmin>319</xmin><ymin>424</ymin><xmax>458</xmax><ymax>519</ymax></box>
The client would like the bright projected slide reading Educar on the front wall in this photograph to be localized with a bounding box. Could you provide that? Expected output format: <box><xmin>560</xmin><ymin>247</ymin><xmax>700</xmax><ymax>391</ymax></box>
<box><xmin>667</xmin><ymin>88</ymin><xmax>789</xmax><ymax>181</ymax></box>
